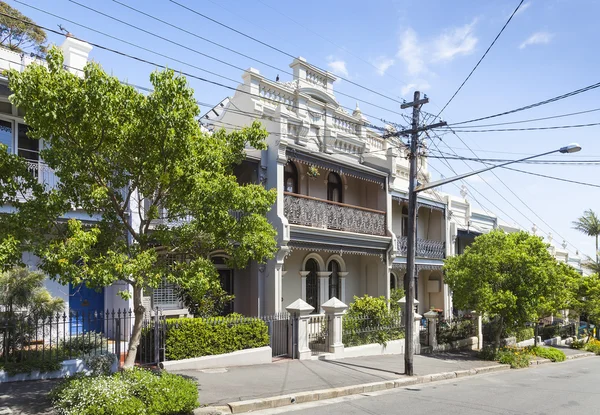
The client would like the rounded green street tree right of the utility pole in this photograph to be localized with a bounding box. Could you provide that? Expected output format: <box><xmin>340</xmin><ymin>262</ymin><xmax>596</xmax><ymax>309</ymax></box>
<box><xmin>444</xmin><ymin>230</ymin><xmax>568</xmax><ymax>346</ymax></box>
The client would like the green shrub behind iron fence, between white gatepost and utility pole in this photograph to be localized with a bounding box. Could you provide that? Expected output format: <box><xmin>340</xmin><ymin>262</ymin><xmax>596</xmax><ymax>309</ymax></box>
<box><xmin>342</xmin><ymin>295</ymin><xmax>404</xmax><ymax>347</ymax></box>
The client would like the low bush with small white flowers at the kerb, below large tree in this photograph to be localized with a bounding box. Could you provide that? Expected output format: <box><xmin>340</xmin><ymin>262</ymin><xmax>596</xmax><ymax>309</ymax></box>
<box><xmin>50</xmin><ymin>368</ymin><xmax>198</xmax><ymax>415</ymax></box>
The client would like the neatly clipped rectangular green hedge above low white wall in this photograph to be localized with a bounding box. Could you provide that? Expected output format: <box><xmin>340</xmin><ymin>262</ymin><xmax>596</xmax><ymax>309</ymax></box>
<box><xmin>165</xmin><ymin>314</ymin><xmax>269</xmax><ymax>360</ymax></box>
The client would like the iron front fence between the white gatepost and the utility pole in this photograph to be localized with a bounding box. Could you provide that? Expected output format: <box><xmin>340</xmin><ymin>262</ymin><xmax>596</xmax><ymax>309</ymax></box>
<box><xmin>342</xmin><ymin>314</ymin><xmax>405</xmax><ymax>347</ymax></box>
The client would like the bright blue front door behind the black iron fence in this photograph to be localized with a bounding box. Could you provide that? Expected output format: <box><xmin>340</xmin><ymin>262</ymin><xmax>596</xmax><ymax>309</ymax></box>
<box><xmin>69</xmin><ymin>284</ymin><xmax>104</xmax><ymax>334</ymax></box>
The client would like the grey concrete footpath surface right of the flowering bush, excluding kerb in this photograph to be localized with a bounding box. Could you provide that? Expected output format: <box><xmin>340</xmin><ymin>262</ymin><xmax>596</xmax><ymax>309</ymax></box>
<box><xmin>173</xmin><ymin>352</ymin><xmax>498</xmax><ymax>406</ymax></box>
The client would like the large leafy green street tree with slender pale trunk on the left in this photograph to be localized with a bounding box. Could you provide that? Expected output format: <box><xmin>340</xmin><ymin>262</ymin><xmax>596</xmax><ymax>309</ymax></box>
<box><xmin>8</xmin><ymin>48</ymin><xmax>277</xmax><ymax>366</ymax></box>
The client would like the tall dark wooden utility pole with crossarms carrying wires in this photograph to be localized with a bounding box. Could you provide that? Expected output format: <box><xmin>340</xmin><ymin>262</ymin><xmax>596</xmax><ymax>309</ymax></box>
<box><xmin>398</xmin><ymin>91</ymin><xmax>446</xmax><ymax>376</ymax></box>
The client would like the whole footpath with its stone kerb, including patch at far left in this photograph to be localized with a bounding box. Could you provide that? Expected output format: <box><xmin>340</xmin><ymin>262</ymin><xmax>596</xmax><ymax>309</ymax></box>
<box><xmin>0</xmin><ymin>349</ymin><xmax>590</xmax><ymax>415</ymax></box>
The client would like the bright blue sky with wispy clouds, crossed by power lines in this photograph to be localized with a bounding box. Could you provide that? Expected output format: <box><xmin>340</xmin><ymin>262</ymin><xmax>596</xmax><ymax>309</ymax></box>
<box><xmin>7</xmin><ymin>0</ymin><xmax>600</xmax><ymax>255</ymax></box>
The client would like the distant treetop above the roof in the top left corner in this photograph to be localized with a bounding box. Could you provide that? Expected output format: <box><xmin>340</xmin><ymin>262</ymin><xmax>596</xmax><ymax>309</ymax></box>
<box><xmin>0</xmin><ymin>1</ymin><xmax>46</xmax><ymax>53</ymax></box>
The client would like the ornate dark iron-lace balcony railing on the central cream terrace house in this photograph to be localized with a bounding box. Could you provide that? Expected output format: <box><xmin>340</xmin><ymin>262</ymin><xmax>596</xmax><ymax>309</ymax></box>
<box><xmin>283</xmin><ymin>192</ymin><xmax>386</xmax><ymax>236</ymax></box>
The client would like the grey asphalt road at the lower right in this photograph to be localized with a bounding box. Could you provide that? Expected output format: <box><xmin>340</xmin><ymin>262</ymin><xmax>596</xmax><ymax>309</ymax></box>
<box><xmin>256</xmin><ymin>357</ymin><xmax>600</xmax><ymax>415</ymax></box>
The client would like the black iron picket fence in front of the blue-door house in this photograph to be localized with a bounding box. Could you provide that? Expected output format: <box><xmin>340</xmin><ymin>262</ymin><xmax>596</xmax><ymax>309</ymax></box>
<box><xmin>0</xmin><ymin>310</ymin><xmax>165</xmax><ymax>368</ymax></box>
